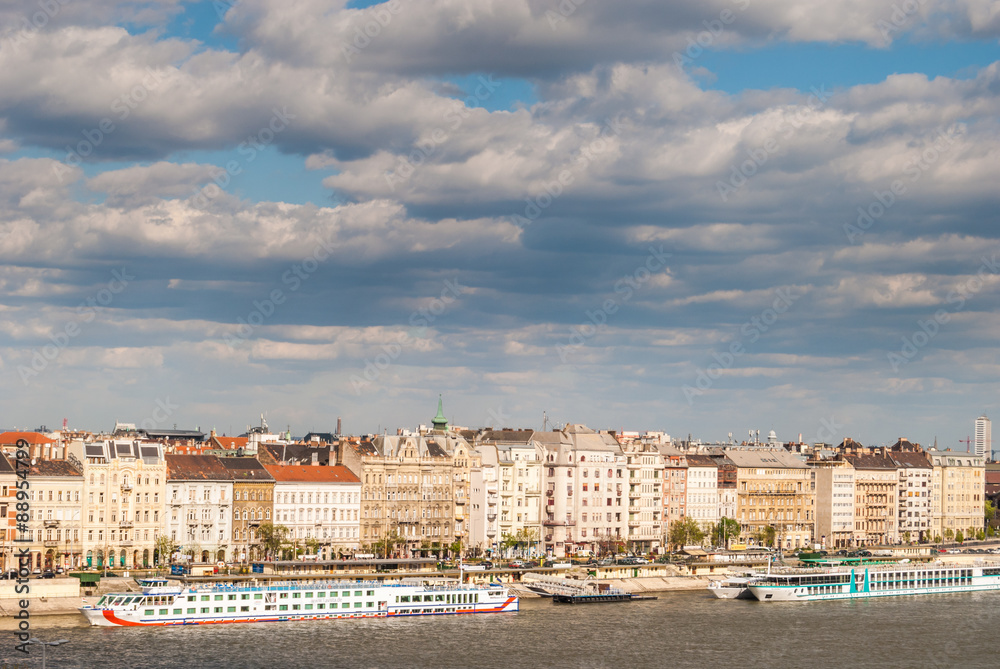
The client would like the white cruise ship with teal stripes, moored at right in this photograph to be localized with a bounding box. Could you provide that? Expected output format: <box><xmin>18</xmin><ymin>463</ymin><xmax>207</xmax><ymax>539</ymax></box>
<box><xmin>747</xmin><ymin>562</ymin><xmax>1000</xmax><ymax>602</ymax></box>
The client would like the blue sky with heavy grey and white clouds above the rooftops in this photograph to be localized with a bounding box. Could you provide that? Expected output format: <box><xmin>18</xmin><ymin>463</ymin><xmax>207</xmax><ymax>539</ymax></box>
<box><xmin>0</xmin><ymin>0</ymin><xmax>1000</xmax><ymax>450</ymax></box>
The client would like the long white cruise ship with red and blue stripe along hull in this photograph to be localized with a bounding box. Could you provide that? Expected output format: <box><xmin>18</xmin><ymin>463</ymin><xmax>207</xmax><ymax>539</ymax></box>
<box><xmin>80</xmin><ymin>578</ymin><xmax>518</xmax><ymax>627</ymax></box>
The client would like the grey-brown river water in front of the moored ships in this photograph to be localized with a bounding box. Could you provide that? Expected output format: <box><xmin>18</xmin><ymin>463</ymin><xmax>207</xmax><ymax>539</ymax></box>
<box><xmin>0</xmin><ymin>591</ymin><xmax>1000</xmax><ymax>669</ymax></box>
